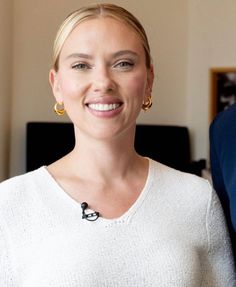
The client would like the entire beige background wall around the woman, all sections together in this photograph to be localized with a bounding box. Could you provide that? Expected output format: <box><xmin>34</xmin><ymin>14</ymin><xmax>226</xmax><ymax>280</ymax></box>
<box><xmin>0</xmin><ymin>0</ymin><xmax>236</xmax><ymax>181</ymax></box>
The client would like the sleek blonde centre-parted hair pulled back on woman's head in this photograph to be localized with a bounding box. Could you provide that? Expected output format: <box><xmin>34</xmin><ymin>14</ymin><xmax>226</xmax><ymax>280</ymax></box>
<box><xmin>53</xmin><ymin>3</ymin><xmax>151</xmax><ymax>71</ymax></box>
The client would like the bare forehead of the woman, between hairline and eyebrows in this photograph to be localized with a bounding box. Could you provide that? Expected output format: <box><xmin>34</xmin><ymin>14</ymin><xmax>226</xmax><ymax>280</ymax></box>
<box><xmin>61</xmin><ymin>17</ymin><xmax>144</xmax><ymax>52</ymax></box>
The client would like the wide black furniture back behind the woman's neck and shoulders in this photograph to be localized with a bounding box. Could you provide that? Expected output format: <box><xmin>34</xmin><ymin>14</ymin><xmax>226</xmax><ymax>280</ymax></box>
<box><xmin>26</xmin><ymin>122</ymin><xmax>206</xmax><ymax>175</ymax></box>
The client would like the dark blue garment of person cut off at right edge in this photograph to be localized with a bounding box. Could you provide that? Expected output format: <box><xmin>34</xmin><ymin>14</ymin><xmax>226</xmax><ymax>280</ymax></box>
<box><xmin>210</xmin><ymin>104</ymin><xmax>236</xmax><ymax>259</ymax></box>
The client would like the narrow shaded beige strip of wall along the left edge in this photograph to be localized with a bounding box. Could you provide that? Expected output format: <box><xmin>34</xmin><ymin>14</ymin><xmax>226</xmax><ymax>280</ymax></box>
<box><xmin>0</xmin><ymin>0</ymin><xmax>12</xmax><ymax>181</ymax></box>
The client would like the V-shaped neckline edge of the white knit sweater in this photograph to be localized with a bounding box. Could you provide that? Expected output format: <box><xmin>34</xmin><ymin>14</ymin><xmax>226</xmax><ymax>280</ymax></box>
<box><xmin>39</xmin><ymin>158</ymin><xmax>155</xmax><ymax>225</ymax></box>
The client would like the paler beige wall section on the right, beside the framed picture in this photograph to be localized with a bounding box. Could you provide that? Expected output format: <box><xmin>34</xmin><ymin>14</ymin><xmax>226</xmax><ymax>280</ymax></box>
<box><xmin>187</xmin><ymin>0</ymin><xmax>236</xmax><ymax>162</ymax></box>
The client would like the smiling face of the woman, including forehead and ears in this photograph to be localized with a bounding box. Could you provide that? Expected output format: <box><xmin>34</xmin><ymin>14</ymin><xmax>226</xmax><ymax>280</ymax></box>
<box><xmin>50</xmin><ymin>17</ymin><xmax>153</xmax><ymax>141</ymax></box>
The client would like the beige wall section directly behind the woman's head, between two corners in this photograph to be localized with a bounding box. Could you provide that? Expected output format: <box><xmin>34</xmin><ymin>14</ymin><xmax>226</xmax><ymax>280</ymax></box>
<box><xmin>10</xmin><ymin>0</ymin><xmax>187</xmax><ymax>176</ymax></box>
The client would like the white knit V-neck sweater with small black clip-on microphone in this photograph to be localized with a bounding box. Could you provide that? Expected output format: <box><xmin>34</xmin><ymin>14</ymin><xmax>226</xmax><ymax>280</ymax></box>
<box><xmin>0</xmin><ymin>160</ymin><xmax>236</xmax><ymax>287</ymax></box>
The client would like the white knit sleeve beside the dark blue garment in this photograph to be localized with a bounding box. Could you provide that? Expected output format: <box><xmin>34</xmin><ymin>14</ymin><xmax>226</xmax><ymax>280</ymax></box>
<box><xmin>202</xmin><ymin>183</ymin><xmax>236</xmax><ymax>287</ymax></box>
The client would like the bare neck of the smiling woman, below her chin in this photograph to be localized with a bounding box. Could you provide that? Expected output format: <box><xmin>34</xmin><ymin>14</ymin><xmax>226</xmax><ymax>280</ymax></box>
<box><xmin>67</xmin><ymin>125</ymin><xmax>140</xmax><ymax>179</ymax></box>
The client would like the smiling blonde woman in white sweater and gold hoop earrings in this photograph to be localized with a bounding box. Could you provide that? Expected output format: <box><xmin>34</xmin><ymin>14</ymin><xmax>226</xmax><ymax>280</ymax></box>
<box><xmin>0</xmin><ymin>4</ymin><xmax>235</xmax><ymax>287</ymax></box>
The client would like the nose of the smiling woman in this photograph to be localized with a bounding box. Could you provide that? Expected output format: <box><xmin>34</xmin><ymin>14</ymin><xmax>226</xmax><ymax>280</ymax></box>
<box><xmin>93</xmin><ymin>66</ymin><xmax>115</xmax><ymax>93</ymax></box>
